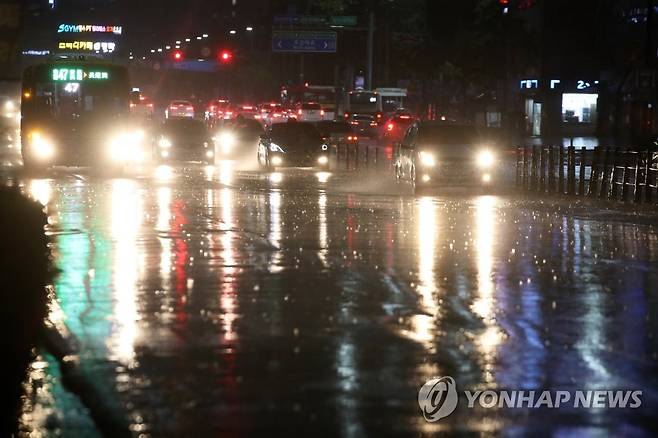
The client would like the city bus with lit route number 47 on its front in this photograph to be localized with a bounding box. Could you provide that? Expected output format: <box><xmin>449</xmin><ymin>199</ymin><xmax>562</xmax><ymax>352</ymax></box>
<box><xmin>21</xmin><ymin>58</ymin><xmax>147</xmax><ymax>168</ymax></box>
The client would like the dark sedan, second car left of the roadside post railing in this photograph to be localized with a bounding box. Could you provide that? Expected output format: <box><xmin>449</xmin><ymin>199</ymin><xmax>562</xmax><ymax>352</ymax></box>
<box><xmin>258</xmin><ymin>122</ymin><xmax>329</xmax><ymax>168</ymax></box>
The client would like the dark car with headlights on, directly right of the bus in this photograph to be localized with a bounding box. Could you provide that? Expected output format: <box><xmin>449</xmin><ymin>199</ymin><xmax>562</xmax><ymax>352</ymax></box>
<box><xmin>155</xmin><ymin>118</ymin><xmax>215</xmax><ymax>164</ymax></box>
